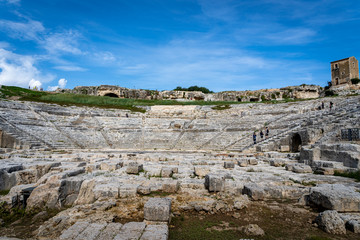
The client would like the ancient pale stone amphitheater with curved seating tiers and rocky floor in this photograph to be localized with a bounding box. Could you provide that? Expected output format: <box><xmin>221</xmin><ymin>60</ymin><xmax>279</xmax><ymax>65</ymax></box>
<box><xmin>0</xmin><ymin>96</ymin><xmax>360</xmax><ymax>239</ymax></box>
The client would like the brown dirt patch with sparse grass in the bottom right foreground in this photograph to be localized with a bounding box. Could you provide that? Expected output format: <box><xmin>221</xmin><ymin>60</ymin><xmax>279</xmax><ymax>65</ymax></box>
<box><xmin>169</xmin><ymin>201</ymin><xmax>360</xmax><ymax>240</ymax></box>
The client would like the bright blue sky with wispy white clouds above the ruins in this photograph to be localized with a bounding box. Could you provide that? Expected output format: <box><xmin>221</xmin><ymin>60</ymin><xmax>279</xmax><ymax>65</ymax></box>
<box><xmin>0</xmin><ymin>0</ymin><xmax>360</xmax><ymax>91</ymax></box>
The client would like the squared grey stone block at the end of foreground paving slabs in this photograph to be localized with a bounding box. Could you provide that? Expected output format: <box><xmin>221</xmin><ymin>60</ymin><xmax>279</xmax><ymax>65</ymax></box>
<box><xmin>144</xmin><ymin>198</ymin><xmax>171</xmax><ymax>222</ymax></box>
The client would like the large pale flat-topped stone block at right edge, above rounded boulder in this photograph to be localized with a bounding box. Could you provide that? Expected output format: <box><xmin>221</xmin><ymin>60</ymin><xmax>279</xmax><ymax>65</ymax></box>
<box><xmin>309</xmin><ymin>184</ymin><xmax>360</xmax><ymax>212</ymax></box>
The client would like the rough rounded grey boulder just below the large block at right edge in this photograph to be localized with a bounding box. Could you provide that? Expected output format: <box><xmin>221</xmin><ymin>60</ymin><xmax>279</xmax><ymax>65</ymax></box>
<box><xmin>315</xmin><ymin>210</ymin><xmax>346</xmax><ymax>234</ymax></box>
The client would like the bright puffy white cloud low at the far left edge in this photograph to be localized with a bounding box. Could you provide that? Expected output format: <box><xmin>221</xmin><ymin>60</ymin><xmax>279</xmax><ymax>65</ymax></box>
<box><xmin>0</xmin><ymin>49</ymin><xmax>54</xmax><ymax>88</ymax></box>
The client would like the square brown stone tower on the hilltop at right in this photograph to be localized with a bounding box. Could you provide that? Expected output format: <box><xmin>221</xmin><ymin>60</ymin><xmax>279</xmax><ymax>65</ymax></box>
<box><xmin>331</xmin><ymin>57</ymin><xmax>359</xmax><ymax>86</ymax></box>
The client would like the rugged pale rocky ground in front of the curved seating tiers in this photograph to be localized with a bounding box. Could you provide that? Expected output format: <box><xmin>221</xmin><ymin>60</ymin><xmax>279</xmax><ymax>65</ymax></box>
<box><xmin>1</xmin><ymin>150</ymin><xmax>360</xmax><ymax>239</ymax></box>
